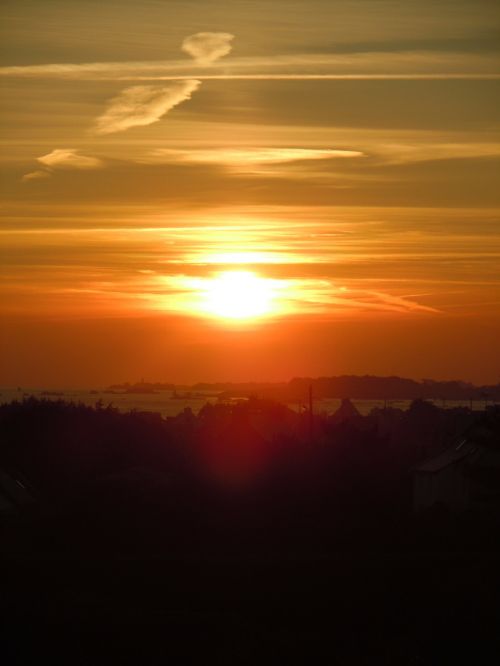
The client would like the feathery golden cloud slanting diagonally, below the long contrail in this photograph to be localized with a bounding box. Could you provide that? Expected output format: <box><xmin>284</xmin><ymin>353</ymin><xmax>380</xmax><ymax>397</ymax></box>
<box><xmin>95</xmin><ymin>79</ymin><xmax>200</xmax><ymax>134</ymax></box>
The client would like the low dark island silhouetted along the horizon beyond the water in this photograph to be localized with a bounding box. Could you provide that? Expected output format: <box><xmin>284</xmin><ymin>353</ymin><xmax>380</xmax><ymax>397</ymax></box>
<box><xmin>108</xmin><ymin>375</ymin><xmax>500</xmax><ymax>402</ymax></box>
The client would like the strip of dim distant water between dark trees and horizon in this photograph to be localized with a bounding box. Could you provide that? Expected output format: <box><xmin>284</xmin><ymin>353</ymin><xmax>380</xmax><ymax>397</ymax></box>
<box><xmin>0</xmin><ymin>388</ymin><xmax>484</xmax><ymax>417</ymax></box>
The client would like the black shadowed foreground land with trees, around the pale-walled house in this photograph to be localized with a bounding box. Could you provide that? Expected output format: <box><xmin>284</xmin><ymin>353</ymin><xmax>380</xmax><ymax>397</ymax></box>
<box><xmin>0</xmin><ymin>399</ymin><xmax>500</xmax><ymax>665</ymax></box>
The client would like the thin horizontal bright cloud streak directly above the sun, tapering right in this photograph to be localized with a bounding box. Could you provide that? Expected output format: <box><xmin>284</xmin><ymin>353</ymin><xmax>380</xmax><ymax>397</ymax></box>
<box><xmin>145</xmin><ymin>147</ymin><xmax>363</xmax><ymax>172</ymax></box>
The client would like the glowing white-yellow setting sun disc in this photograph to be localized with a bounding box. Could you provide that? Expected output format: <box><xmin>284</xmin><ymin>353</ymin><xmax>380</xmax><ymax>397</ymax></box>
<box><xmin>203</xmin><ymin>271</ymin><xmax>276</xmax><ymax>320</ymax></box>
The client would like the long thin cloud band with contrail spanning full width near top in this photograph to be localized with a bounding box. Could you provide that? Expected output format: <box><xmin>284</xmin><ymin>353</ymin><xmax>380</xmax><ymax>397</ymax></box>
<box><xmin>0</xmin><ymin>52</ymin><xmax>500</xmax><ymax>81</ymax></box>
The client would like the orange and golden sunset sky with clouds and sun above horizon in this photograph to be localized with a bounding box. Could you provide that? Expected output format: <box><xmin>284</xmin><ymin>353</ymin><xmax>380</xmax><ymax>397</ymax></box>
<box><xmin>0</xmin><ymin>0</ymin><xmax>500</xmax><ymax>387</ymax></box>
